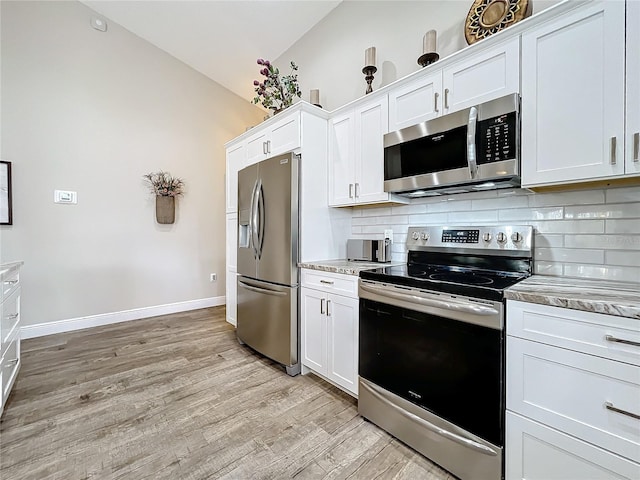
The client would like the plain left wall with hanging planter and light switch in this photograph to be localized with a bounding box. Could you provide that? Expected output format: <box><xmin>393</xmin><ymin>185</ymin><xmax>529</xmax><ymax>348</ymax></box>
<box><xmin>1</xmin><ymin>1</ymin><xmax>264</xmax><ymax>325</ymax></box>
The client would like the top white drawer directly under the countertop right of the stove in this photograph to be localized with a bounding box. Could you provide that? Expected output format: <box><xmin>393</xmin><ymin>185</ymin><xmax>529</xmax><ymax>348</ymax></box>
<box><xmin>507</xmin><ymin>300</ymin><xmax>640</xmax><ymax>366</ymax></box>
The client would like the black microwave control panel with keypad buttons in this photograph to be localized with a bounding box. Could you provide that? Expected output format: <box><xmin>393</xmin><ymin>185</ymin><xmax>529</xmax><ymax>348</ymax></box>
<box><xmin>476</xmin><ymin>112</ymin><xmax>518</xmax><ymax>165</ymax></box>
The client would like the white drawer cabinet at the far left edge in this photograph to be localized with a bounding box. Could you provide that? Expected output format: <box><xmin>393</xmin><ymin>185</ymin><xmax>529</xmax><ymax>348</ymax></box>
<box><xmin>0</xmin><ymin>262</ymin><xmax>22</xmax><ymax>415</ymax></box>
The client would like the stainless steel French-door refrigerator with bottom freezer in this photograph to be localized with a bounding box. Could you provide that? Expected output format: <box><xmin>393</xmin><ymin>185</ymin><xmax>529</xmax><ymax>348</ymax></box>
<box><xmin>237</xmin><ymin>153</ymin><xmax>300</xmax><ymax>375</ymax></box>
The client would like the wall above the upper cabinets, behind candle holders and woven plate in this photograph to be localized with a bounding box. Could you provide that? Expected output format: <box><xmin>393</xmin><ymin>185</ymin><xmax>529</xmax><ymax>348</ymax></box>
<box><xmin>270</xmin><ymin>0</ymin><xmax>559</xmax><ymax>110</ymax></box>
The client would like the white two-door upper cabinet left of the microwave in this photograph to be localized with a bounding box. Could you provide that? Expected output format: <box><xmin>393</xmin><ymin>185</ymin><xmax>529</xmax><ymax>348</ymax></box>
<box><xmin>329</xmin><ymin>95</ymin><xmax>408</xmax><ymax>207</ymax></box>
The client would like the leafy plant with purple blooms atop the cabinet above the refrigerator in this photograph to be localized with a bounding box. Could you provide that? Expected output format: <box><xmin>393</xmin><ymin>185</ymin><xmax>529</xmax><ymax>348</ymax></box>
<box><xmin>253</xmin><ymin>58</ymin><xmax>302</xmax><ymax>113</ymax></box>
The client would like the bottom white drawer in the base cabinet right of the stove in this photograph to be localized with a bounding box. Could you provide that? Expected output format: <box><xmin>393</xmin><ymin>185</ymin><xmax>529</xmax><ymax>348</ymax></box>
<box><xmin>505</xmin><ymin>412</ymin><xmax>640</xmax><ymax>480</ymax></box>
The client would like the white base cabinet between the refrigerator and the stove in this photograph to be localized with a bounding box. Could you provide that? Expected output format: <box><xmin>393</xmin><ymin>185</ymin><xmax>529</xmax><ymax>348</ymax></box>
<box><xmin>300</xmin><ymin>269</ymin><xmax>358</xmax><ymax>396</ymax></box>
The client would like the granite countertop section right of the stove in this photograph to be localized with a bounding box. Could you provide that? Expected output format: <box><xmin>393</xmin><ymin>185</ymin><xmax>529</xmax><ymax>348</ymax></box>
<box><xmin>504</xmin><ymin>275</ymin><xmax>640</xmax><ymax>320</ymax></box>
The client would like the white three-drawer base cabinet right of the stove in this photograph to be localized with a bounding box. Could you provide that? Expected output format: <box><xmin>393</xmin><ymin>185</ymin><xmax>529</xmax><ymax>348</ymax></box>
<box><xmin>505</xmin><ymin>300</ymin><xmax>640</xmax><ymax>480</ymax></box>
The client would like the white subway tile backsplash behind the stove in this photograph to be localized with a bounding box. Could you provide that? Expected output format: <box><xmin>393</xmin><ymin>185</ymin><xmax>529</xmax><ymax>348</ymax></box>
<box><xmin>351</xmin><ymin>187</ymin><xmax>640</xmax><ymax>282</ymax></box>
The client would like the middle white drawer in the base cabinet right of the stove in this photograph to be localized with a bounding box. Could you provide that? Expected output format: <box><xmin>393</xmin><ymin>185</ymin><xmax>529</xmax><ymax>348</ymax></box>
<box><xmin>507</xmin><ymin>337</ymin><xmax>640</xmax><ymax>462</ymax></box>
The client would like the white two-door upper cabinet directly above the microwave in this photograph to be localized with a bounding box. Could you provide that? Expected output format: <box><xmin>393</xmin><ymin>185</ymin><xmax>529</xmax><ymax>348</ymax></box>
<box><xmin>389</xmin><ymin>37</ymin><xmax>520</xmax><ymax>132</ymax></box>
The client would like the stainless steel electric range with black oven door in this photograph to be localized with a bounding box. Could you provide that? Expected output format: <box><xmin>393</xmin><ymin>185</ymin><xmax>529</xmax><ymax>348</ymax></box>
<box><xmin>358</xmin><ymin>226</ymin><xmax>533</xmax><ymax>480</ymax></box>
